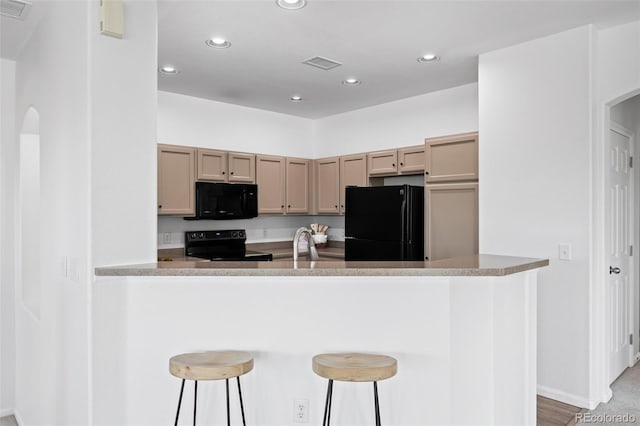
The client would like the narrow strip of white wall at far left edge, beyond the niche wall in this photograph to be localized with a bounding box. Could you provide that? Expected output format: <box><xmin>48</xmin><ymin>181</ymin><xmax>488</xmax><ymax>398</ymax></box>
<box><xmin>0</xmin><ymin>59</ymin><xmax>17</xmax><ymax>417</ymax></box>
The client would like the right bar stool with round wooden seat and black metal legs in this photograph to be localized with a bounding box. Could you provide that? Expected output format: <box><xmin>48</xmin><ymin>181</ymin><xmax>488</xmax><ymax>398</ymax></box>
<box><xmin>313</xmin><ymin>353</ymin><xmax>398</xmax><ymax>426</ymax></box>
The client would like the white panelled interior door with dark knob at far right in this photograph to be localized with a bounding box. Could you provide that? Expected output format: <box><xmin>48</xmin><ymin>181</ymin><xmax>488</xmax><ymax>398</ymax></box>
<box><xmin>607</xmin><ymin>126</ymin><xmax>633</xmax><ymax>383</ymax></box>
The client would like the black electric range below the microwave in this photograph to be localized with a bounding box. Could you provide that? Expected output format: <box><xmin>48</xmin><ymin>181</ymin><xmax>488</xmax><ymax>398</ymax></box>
<box><xmin>184</xmin><ymin>229</ymin><xmax>273</xmax><ymax>261</ymax></box>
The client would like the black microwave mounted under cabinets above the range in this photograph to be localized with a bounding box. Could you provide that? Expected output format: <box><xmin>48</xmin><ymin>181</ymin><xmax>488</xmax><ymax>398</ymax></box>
<box><xmin>192</xmin><ymin>182</ymin><xmax>258</xmax><ymax>219</ymax></box>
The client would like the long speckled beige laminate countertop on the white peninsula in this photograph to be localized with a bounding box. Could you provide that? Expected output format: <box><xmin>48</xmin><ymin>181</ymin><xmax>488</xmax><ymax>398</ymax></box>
<box><xmin>95</xmin><ymin>254</ymin><xmax>549</xmax><ymax>277</ymax></box>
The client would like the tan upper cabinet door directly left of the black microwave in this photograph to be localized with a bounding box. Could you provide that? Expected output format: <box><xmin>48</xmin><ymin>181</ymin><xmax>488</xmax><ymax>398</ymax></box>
<box><xmin>158</xmin><ymin>145</ymin><xmax>196</xmax><ymax>216</ymax></box>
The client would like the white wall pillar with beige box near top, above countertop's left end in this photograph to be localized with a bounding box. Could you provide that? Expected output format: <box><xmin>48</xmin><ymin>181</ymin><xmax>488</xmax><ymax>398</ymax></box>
<box><xmin>90</xmin><ymin>0</ymin><xmax>158</xmax><ymax>266</ymax></box>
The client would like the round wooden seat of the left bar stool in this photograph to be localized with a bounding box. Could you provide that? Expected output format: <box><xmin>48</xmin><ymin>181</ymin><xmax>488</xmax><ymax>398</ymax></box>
<box><xmin>169</xmin><ymin>351</ymin><xmax>253</xmax><ymax>380</ymax></box>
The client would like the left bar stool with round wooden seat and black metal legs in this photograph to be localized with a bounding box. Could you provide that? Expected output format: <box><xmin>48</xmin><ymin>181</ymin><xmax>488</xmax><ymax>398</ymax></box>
<box><xmin>169</xmin><ymin>351</ymin><xmax>253</xmax><ymax>426</ymax></box>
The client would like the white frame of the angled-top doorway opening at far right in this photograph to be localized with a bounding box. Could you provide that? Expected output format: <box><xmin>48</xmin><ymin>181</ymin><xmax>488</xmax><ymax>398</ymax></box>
<box><xmin>587</xmin><ymin>88</ymin><xmax>640</xmax><ymax>409</ymax></box>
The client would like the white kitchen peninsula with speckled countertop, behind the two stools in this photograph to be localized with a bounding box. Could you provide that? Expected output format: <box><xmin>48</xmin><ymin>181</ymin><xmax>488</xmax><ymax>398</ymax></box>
<box><xmin>93</xmin><ymin>255</ymin><xmax>549</xmax><ymax>426</ymax></box>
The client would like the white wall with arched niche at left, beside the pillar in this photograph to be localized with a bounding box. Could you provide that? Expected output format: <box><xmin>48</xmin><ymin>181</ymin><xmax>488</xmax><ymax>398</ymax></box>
<box><xmin>10</xmin><ymin>2</ymin><xmax>91</xmax><ymax>424</ymax></box>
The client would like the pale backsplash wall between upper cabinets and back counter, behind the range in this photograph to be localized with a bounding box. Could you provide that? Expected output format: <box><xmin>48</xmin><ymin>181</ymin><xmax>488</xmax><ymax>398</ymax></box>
<box><xmin>158</xmin><ymin>215</ymin><xmax>344</xmax><ymax>249</ymax></box>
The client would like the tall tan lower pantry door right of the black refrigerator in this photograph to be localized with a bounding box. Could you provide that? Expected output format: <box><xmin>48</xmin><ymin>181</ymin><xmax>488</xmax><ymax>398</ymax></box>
<box><xmin>424</xmin><ymin>183</ymin><xmax>478</xmax><ymax>260</ymax></box>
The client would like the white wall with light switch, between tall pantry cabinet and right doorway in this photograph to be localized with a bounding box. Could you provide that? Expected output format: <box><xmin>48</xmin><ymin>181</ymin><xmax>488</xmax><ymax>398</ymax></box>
<box><xmin>479</xmin><ymin>27</ymin><xmax>592</xmax><ymax>406</ymax></box>
